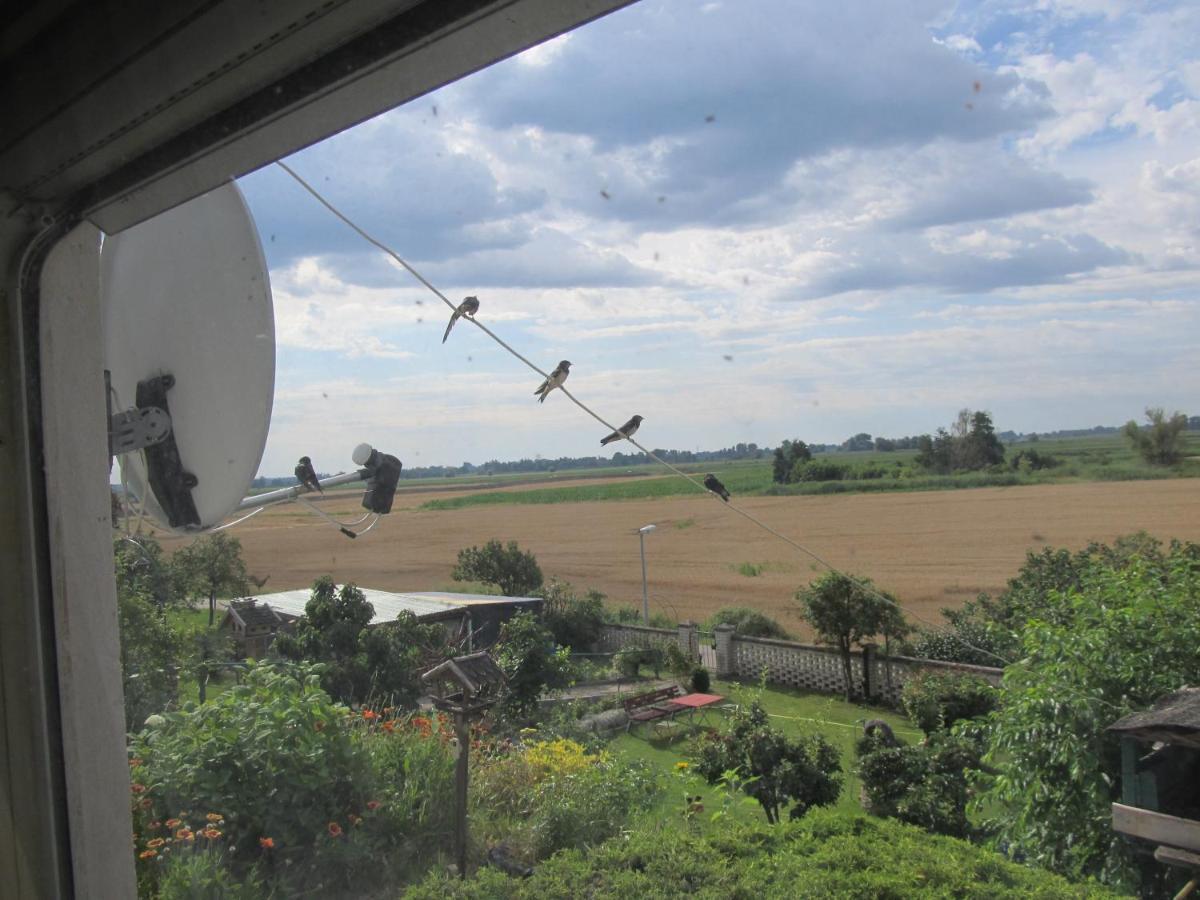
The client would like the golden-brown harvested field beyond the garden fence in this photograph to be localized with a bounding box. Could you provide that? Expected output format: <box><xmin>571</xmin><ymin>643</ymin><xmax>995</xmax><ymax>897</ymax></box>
<box><xmin>166</xmin><ymin>479</ymin><xmax>1200</xmax><ymax>632</ymax></box>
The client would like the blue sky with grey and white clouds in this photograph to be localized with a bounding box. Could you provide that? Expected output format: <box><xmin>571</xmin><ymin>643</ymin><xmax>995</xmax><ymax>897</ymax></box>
<box><xmin>240</xmin><ymin>0</ymin><xmax>1200</xmax><ymax>475</ymax></box>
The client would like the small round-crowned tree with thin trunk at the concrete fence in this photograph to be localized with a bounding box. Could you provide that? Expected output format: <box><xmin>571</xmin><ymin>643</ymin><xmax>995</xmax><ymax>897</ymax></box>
<box><xmin>796</xmin><ymin>572</ymin><xmax>894</xmax><ymax>701</ymax></box>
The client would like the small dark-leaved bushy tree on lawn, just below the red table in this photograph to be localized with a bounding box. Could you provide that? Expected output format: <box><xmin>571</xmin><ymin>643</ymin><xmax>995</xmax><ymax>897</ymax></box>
<box><xmin>696</xmin><ymin>700</ymin><xmax>841</xmax><ymax>824</ymax></box>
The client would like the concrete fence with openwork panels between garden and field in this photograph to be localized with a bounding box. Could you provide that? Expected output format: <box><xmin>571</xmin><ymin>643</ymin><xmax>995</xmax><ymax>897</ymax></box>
<box><xmin>600</xmin><ymin>622</ymin><xmax>1003</xmax><ymax>704</ymax></box>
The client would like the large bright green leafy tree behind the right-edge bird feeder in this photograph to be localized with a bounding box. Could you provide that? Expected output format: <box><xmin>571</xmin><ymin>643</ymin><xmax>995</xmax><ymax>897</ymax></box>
<box><xmin>979</xmin><ymin>541</ymin><xmax>1200</xmax><ymax>889</ymax></box>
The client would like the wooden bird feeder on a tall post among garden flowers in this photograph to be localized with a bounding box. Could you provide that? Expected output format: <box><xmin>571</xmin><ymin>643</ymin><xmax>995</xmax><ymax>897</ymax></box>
<box><xmin>421</xmin><ymin>650</ymin><xmax>506</xmax><ymax>878</ymax></box>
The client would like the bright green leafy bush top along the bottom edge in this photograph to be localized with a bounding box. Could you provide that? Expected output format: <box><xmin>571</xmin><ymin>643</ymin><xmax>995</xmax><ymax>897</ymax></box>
<box><xmin>404</xmin><ymin>810</ymin><xmax>1117</xmax><ymax>900</ymax></box>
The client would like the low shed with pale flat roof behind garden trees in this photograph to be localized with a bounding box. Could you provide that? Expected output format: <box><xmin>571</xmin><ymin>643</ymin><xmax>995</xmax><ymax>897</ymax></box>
<box><xmin>229</xmin><ymin>584</ymin><xmax>542</xmax><ymax>655</ymax></box>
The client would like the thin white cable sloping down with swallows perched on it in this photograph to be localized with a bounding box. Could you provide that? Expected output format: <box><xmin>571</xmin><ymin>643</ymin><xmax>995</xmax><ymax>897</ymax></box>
<box><xmin>275</xmin><ymin>161</ymin><xmax>1010</xmax><ymax>666</ymax></box>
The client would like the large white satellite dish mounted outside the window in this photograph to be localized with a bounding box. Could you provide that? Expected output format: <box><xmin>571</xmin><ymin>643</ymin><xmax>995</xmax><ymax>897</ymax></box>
<box><xmin>100</xmin><ymin>181</ymin><xmax>275</xmax><ymax>532</ymax></box>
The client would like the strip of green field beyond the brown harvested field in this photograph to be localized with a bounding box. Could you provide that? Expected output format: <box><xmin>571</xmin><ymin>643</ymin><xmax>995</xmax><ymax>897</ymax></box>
<box><xmin>420</xmin><ymin>432</ymin><xmax>1200</xmax><ymax>510</ymax></box>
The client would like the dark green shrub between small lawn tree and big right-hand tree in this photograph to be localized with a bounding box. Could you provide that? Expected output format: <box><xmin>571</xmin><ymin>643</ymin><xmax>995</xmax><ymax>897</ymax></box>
<box><xmin>856</xmin><ymin>732</ymin><xmax>979</xmax><ymax>838</ymax></box>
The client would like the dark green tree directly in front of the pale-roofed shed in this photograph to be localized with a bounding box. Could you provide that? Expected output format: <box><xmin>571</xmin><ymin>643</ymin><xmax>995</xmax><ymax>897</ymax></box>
<box><xmin>275</xmin><ymin>576</ymin><xmax>446</xmax><ymax>707</ymax></box>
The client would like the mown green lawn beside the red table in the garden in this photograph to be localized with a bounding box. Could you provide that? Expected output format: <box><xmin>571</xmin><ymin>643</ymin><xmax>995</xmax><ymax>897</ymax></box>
<box><xmin>610</xmin><ymin>682</ymin><xmax>923</xmax><ymax>823</ymax></box>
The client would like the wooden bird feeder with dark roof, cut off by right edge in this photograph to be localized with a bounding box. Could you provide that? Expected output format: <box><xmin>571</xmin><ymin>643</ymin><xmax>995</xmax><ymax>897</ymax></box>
<box><xmin>1108</xmin><ymin>688</ymin><xmax>1200</xmax><ymax>896</ymax></box>
